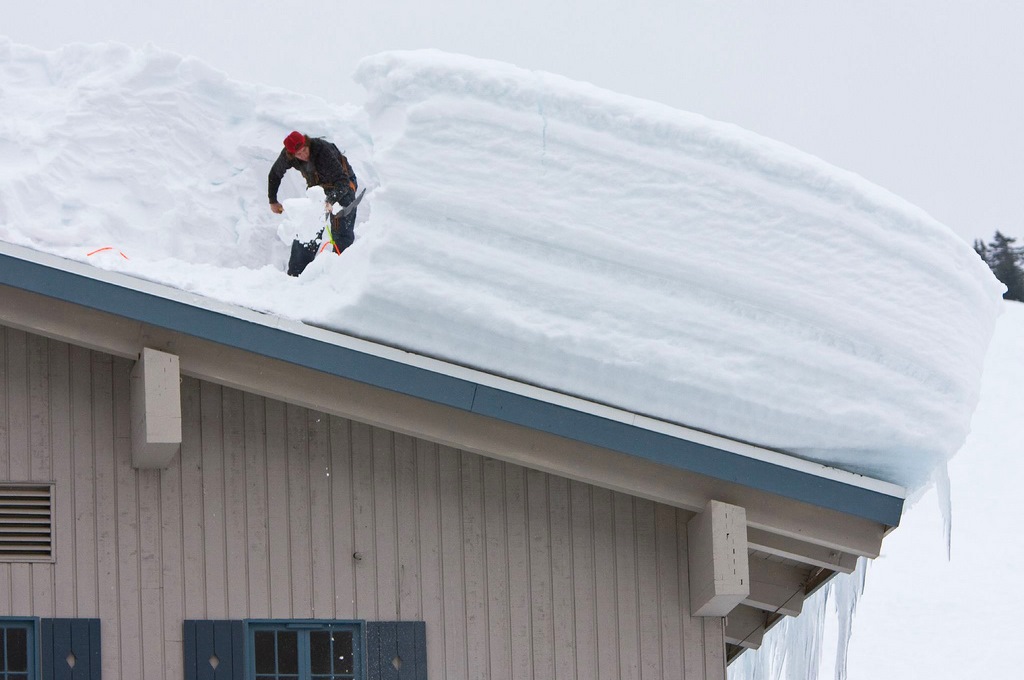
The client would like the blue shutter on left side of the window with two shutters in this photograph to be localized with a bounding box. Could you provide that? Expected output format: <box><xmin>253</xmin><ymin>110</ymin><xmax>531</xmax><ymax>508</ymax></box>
<box><xmin>182</xmin><ymin>621</ymin><xmax>246</xmax><ymax>680</ymax></box>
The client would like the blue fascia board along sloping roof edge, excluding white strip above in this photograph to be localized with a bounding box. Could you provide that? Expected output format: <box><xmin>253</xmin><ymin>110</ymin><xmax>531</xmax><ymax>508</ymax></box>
<box><xmin>0</xmin><ymin>253</ymin><xmax>903</xmax><ymax>526</ymax></box>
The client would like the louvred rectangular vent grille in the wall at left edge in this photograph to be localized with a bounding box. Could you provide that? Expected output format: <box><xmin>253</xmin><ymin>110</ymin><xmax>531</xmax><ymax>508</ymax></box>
<box><xmin>0</xmin><ymin>484</ymin><xmax>53</xmax><ymax>562</ymax></box>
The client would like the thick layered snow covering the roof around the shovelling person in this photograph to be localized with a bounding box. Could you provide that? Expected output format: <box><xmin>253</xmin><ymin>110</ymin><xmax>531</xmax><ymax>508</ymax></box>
<box><xmin>0</xmin><ymin>40</ymin><xmax>1001</xmax><ymax>487</ymax></box>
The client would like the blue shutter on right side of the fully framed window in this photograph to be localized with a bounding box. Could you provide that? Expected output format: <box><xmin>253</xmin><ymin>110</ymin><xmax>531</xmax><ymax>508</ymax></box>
<box><xmin>367</xmin><ymin>621</ymin><xmax>427</xmax><ymax>680</ymax></box>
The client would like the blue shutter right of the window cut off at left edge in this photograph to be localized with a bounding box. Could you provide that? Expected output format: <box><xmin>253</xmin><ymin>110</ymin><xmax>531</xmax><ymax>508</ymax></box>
<box><xmin>39</xmin><ymin>619</ymin><xmax>102</xmax><ymax>680</ymax></box>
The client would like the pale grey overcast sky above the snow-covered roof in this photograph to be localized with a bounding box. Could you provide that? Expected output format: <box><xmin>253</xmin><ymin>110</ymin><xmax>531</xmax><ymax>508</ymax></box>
<box><xmin>0</xmin><ymin>0</ymin><xmax>1024</xmax><ymax>245</ymax></box>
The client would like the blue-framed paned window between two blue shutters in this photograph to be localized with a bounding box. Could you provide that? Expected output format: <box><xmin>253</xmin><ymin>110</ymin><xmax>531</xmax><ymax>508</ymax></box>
<box><xmin>246</xmin><ymin>621</ymin><xmax>362</xmax><ymax>680</ymax></box>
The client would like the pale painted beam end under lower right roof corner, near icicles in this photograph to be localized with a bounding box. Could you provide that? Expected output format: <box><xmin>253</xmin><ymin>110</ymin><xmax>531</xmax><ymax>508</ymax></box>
<box><xmin>686</xmin><ymin>501</ymin><xmax>751</xmax><ymax>617</ymax></box>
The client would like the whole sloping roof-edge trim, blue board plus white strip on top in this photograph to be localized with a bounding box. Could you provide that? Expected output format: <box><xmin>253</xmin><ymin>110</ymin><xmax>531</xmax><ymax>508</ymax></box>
<box><xmin>0</xmin><ymin>242</ymin><xmax>906</xmax><ymax>526</ymax></box>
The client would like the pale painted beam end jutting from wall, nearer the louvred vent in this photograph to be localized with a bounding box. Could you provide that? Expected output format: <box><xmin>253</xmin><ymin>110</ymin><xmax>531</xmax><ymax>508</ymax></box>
<box><xmin>131</xmin><ymin>347</ymin><xmax>181</xmax><ymax>469</ymax></box>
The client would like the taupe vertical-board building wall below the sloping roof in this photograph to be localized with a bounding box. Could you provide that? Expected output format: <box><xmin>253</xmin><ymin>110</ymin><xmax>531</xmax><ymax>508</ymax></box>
<box><xmin>0</xmin><ymin>327</ymin><xmax>725</xmax><ymax>680</ymax></box>
